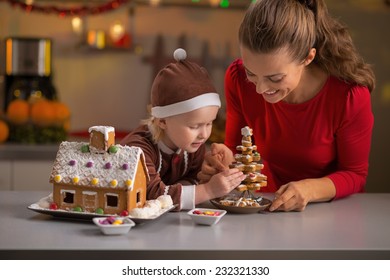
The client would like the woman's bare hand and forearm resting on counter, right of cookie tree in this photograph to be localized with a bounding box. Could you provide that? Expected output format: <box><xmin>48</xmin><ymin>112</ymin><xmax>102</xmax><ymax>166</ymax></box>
<box><xmin>269</xmin><ymin>177</ymin><xmax>336</xmax><ymax>212</ymax></box>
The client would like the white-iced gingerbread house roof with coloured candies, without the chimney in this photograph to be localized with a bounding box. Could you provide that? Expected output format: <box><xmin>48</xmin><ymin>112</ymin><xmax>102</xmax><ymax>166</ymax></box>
<box><xmin>50</xmin><ymin>141</ymin><xmax>149</xmax><ymax>189</ymax></box>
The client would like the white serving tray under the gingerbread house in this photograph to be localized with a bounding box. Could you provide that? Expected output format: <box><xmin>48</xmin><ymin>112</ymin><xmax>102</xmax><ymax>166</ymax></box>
<box><xmin>27</xmin><ymin>203</ymin><xmax>177</xmax><ymax>224</ymax></box>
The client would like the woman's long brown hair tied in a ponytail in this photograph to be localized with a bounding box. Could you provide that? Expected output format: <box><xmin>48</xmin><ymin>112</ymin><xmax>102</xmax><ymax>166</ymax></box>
<box><xmin>239</xmin><ymin>0</ymin><xmax>375</xmax><ymax>92</ymax></box>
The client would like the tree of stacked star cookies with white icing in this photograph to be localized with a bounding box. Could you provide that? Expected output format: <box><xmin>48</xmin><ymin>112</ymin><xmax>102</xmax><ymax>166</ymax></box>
<box><xmin>229</xmin><ymin>126</ymin><xmax>267</xmax><ymax>192</ymax></box>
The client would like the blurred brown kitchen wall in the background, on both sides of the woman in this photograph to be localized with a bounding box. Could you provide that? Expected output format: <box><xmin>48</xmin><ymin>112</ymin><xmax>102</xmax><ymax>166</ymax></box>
<box><xmin>0</xmin><ymin>0</ymin><xmax>390</xmax><ymax>192</ymax></box>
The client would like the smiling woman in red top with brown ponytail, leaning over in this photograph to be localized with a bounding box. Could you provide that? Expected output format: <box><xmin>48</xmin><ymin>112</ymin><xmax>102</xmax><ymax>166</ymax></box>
<box><xmin>198</xmin><ymin>0</ymin><xmax>375</xmax><ymax>211</ymax></box>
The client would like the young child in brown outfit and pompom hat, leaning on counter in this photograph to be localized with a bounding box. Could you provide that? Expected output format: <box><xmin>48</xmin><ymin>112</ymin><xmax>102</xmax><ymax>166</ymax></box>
<box><xmin>121</xmin><ymin>49</ymin><xmax>245</xmax><ymax>210</ymax></box>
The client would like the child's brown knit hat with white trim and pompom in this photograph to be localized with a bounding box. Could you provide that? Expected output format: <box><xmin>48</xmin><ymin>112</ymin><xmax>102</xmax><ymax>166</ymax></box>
<box><xmin>151</xmin><ymin>49</ymin><xmax>221</xmax><ymax>118</ymax></box>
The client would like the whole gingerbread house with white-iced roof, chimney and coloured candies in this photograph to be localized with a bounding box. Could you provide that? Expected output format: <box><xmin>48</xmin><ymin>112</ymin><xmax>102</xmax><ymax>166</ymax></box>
<box><xmin>50</xmin><ymin>126</ymin><xmax>149</xmax><ymax>214</ymax></box>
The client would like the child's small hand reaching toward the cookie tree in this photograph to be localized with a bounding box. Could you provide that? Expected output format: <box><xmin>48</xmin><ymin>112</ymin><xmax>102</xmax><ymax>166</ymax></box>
<box><xmin>205</xmin><ymin>168</ymin><xmax>246</xmax><ymax>199</ymax></box>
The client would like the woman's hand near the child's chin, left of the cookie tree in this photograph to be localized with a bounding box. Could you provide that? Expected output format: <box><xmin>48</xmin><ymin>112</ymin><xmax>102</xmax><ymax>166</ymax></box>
<box><xmin>198</xmin><ymin>143</ymin><xmax>234</xmax><ymax>183</ymax></box>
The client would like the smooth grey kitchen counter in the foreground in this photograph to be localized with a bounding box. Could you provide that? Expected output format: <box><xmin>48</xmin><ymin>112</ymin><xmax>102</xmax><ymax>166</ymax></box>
<box><xmin>0</xmin><ymin>191</ymin><xmax>390</xmax><ymax>259</ymax></box>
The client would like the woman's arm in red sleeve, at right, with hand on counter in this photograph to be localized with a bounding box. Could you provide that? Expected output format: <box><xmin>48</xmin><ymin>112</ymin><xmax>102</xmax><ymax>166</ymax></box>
<box><xmin>270</xmin><ymin>86</ymin><xmax>374</xmax><ymax>211</ymax></box>
